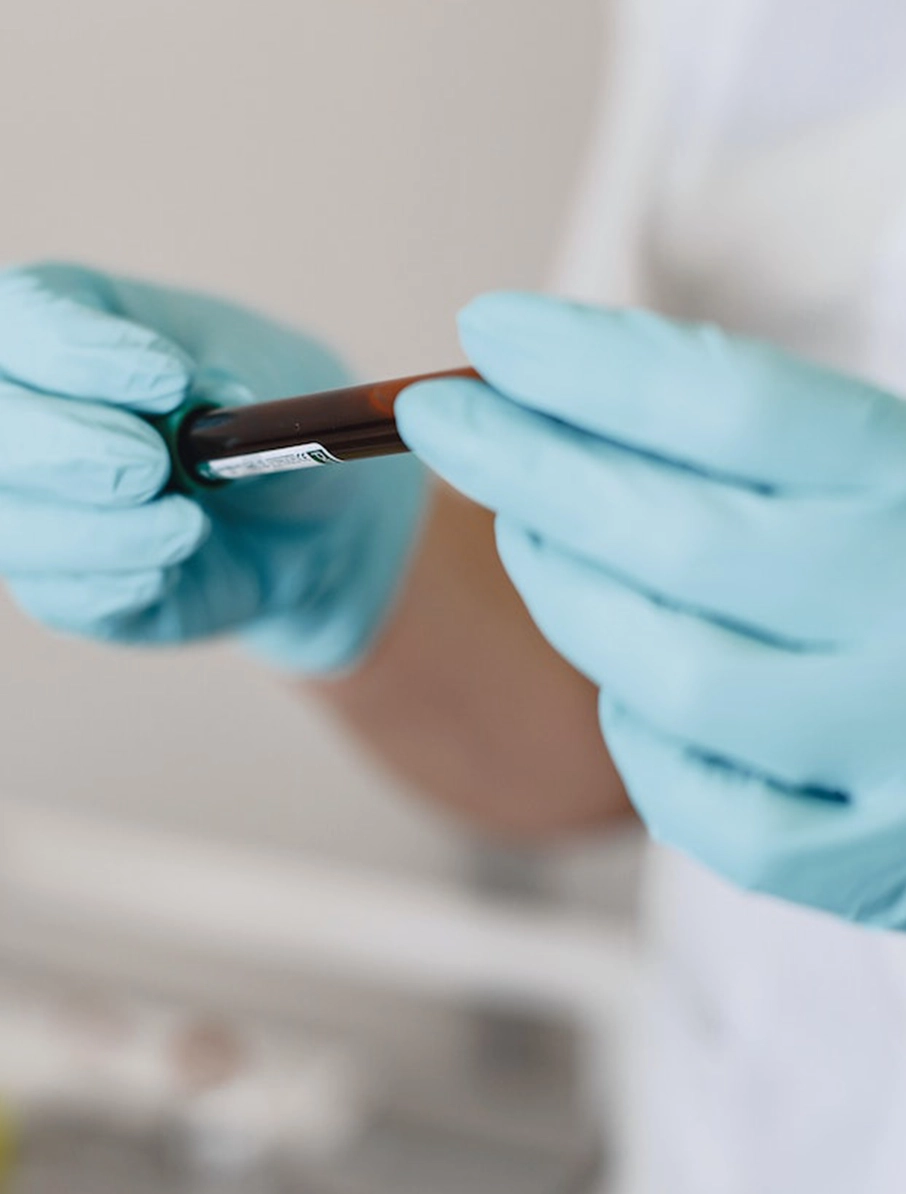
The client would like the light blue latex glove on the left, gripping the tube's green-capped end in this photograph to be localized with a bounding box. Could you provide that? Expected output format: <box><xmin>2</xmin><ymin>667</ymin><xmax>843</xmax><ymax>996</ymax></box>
<box><xmin>0</xmin><ymin>266</ymin><xmax>423</xmax><ymax>672</ymax></box>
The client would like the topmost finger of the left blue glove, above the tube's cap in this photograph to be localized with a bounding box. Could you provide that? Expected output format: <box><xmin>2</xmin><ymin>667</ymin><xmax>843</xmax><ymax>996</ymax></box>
<box><xmin>0</xmin><ymin>266</ymin><xmax>191</xmax><ymax>414</ymax></box>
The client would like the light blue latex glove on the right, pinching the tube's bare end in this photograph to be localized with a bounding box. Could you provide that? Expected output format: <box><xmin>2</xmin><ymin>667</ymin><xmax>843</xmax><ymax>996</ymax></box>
<box><xmin>397</xmin><ymin>295</ymin><xmax>906</xmax><ymax>928</ymax></box>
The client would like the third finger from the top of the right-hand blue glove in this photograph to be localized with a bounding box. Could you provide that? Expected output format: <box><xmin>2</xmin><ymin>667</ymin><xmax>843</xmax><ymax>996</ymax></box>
<box><xmin>498</xmin><ymin>519</ymin><xmax>862</xmax><ymax>789</ymax></box>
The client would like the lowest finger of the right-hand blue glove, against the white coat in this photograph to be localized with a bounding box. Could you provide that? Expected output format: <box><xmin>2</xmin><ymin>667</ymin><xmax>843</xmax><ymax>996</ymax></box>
<box><xmin>599</xmin><ymin>695</ymin><xmax>868</xmax><ymax>919</ymax></box>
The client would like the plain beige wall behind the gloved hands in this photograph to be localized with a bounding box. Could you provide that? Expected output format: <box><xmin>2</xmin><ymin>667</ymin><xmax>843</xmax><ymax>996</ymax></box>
<box><xmin>0</xmin><ymin>0</ymin><xmax>600</xmax><ymax>868</ymax></box>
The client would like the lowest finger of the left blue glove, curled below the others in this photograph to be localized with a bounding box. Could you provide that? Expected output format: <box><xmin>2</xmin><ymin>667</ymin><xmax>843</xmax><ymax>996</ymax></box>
<box><xmin>7</xmin><ymin>568</ymin><xmax>175</xmax><ymax>634</ymax></box>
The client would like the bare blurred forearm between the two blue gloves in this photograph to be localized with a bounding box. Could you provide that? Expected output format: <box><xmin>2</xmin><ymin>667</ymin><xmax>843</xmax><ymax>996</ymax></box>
<box><xmin>313</xmin><ymin>487</ymin><xmax>630</xmax><ymax>839</ymax></box>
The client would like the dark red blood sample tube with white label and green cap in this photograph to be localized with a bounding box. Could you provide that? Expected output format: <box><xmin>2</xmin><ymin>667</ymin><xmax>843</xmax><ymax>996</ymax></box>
<box><xmin>170</xmin><ymin>369</ymin><xmax>479</xmax><ymax>485</ymax></box>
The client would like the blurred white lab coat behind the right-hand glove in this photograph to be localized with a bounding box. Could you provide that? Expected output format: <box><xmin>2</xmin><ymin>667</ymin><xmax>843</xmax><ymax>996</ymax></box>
<box><xmin>561</xmin><ymin>0</ymin><xmax>906</xmax><ymax>1194</ymax></box>
